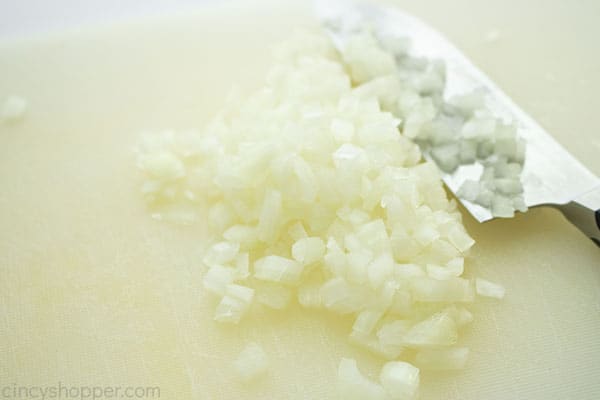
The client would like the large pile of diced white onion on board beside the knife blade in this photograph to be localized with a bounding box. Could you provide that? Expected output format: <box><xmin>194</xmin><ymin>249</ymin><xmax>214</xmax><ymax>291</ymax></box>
<box><xmin>138</xmin><ymin>30</ymin><xmax>506</xmax><ymax>399</ymax></box>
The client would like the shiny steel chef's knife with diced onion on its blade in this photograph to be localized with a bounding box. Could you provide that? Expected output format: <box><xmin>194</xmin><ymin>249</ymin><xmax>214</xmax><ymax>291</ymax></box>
<box><xmin>315</xmin><ymin>0</ymin><xmax>600</xmax><ymax>246</ymax></box>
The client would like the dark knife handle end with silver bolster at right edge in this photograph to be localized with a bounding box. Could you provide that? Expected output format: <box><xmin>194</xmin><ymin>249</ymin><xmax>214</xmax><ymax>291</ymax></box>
<box><xmin>558</xmin><ymin>185</ymin><xmax>600</xmax><ymax>247</ymax></box>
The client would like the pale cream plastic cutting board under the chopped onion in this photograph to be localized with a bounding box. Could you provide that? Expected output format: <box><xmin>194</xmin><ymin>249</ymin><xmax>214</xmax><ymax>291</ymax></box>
<box><xmin>0</xmin><ymin>0</ymin><xmax>600</xmax><ymax>400</ymax></box>
